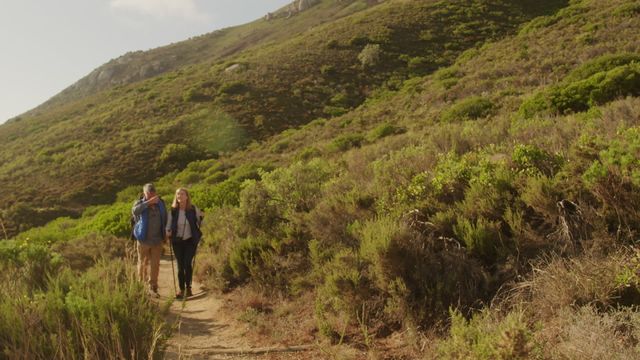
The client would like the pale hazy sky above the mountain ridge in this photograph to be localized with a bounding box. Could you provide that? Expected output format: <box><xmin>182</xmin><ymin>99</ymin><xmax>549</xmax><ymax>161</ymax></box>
<box><xmin>0</xmin><ymin>0</ymin><xmax>292</xmax><ymax>123</ymax></box>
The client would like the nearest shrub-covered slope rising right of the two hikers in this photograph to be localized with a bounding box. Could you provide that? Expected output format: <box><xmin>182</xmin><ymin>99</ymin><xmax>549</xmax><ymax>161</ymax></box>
<box><xmin>5</xmin><ymin>0</ymin><xmax>640</xmax><ymax>359</ymax></box>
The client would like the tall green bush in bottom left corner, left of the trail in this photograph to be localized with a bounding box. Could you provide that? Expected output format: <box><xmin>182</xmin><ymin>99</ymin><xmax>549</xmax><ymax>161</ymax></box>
<box><xmin>0</xmin><ymin>261</ymin><xmax>168</xmax><ymax>359</ymax></box>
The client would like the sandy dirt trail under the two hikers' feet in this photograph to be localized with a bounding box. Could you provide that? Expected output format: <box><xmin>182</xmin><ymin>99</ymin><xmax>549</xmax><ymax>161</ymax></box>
<box><xmin>159</xmin><ymin>256</ymin><xmax>316</xmax><ymax>359</ymax></box>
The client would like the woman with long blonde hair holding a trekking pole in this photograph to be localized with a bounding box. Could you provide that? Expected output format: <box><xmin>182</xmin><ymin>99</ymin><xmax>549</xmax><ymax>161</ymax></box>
<box><xmin>166</xmin><ymin>188</ymin><xmax>203</xmax><ymax>298</ymax></box>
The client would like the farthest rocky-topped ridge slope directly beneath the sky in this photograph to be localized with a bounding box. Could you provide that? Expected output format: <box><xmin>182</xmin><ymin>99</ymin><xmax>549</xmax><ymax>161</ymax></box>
<box><xmin>32</xmin><ymin>1</ymin><xmax>377</xmax><ymax>114</ymax></box>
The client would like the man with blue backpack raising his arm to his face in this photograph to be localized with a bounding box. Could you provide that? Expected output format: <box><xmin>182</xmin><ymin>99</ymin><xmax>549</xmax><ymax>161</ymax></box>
<box><xmin>131</xmin><ymin>184</ymin><xmax>167</xmax><ymax>297</ymax></box>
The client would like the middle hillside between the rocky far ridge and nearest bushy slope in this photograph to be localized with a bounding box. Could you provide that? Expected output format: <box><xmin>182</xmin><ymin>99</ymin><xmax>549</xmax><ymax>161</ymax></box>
<box><xmin>0</xmin><ymin>0</ymin><xmax>564</xmax><ymax>234</ymax></box>
